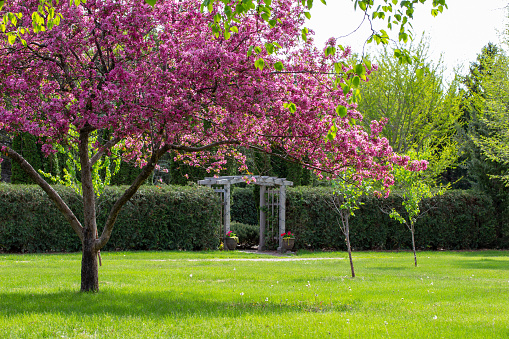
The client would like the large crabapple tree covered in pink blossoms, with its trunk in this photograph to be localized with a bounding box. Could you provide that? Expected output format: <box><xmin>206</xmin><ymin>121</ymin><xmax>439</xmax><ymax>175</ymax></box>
<box><xmin>0</xmin><ymin>0</ymin><xmax>420</xmax><ymax>291</ymax></box>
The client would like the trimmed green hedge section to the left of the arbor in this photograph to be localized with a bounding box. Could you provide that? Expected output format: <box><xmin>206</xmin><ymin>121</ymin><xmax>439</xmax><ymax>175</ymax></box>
<box><xmin>0</xmin><ymin>184</ymin><xmax>220</xmax><ymax>252</ymax></box>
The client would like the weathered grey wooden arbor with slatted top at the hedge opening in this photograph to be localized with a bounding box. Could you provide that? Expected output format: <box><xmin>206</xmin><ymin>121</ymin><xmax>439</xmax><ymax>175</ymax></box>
<box><xmin>198</xmin><ymin>175</ymin><xmax>293</xmax><ymax>252</ymax></box>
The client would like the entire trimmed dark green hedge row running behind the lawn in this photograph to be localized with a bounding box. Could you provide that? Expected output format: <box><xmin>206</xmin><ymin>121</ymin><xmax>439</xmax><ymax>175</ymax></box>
<box><xmin>0</xmin><ymin>184</ymin><xmax>500</xmax><ymax>252</ymax></box>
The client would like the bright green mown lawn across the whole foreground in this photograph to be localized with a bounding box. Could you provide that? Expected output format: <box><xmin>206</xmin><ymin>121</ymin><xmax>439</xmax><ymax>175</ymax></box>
<box><xmin>0</xmin><ymin>251</ymin><xmax>509</xmax><ymax>338</ymax></box>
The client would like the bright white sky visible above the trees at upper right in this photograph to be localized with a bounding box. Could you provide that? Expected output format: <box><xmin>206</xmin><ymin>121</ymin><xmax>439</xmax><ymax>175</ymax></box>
<box><xmin>306</xmin><ymin>0</ymin><xmax>509</xmax><ymax>82</ymax></box>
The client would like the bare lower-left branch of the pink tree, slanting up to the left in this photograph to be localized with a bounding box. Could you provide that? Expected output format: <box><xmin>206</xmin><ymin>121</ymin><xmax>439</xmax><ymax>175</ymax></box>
<box><xmin>0</xmin><ymin>144</ymin><xmax>83</xmax><ymax>240</ymax></box>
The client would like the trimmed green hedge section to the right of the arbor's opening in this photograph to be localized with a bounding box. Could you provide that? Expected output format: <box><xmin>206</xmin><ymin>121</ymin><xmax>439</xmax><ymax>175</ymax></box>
<box><xmin>232</xmin><ymin>187</ymin><xmax>500</xmax><ymax>250</ymax></box>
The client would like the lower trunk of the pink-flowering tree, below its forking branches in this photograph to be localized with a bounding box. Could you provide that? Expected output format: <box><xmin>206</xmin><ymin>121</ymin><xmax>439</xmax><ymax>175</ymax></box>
<box><xmin>81</xmin><ymin>228</ymin><xmax>99</xmax><ymax>292</ymax></box>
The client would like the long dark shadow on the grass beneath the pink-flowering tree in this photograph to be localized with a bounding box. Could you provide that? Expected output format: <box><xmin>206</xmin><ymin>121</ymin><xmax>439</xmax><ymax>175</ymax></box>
<box><xmin>0</xmin><ymin>291</ymin><xmax>351</xmax><ymax>317</ymax></box>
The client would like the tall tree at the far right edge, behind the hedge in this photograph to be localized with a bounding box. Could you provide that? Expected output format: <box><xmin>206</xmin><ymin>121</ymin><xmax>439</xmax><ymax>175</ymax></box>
<box><xmin>456</xmin><ymin>43</ymin><xmax>509</xmax><ymax>244</ymax></box>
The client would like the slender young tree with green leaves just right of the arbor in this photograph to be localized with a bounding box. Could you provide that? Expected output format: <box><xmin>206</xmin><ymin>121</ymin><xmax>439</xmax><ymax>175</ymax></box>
<box><xmin>326</xmin><ymin>170</ymin><xmax>373</xmax><ymax>278</ymax></box>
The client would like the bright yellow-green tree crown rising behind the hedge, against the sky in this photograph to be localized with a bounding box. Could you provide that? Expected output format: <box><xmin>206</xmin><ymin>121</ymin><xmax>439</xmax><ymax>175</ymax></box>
<box><xmin>359</xmin><ymin>41</ymin><xmax>461</xmax><ymax>181</ymax></box>
